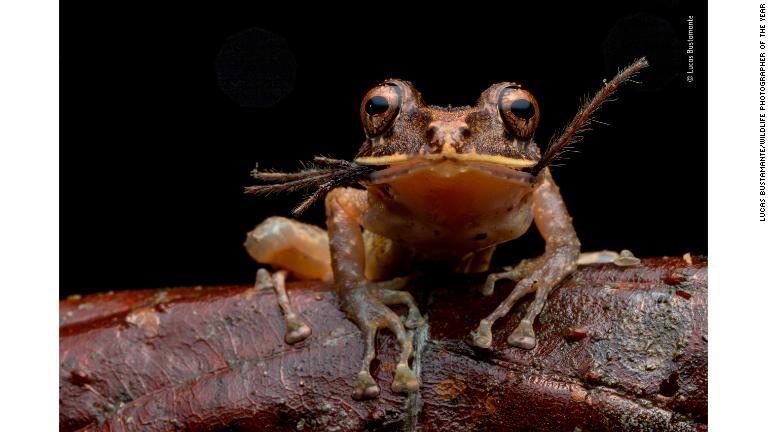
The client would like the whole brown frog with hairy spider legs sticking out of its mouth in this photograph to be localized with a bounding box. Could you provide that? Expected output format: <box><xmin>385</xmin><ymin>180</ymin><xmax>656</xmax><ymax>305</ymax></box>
<box><xmin>245</xmin><ymin>58</ymin><xmax>648</xmax><ymax>400</ymax></box>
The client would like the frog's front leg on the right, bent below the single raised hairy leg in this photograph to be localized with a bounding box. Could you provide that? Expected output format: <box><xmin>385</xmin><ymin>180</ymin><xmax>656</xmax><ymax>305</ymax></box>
<box><xmin>471</xmin><ymin>170</ymin><xmax>581</xmax><ymax>349</ymax></box>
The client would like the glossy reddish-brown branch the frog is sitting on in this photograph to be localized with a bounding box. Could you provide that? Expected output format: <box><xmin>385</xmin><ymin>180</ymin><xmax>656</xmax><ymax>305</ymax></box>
<box><xmin>60</xmin><ymin>259</ymin><xmax>707</xmax><ymax>432</ymax></box>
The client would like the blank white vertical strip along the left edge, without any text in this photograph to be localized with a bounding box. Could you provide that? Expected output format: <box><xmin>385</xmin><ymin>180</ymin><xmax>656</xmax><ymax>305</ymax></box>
<box><xmin>0</xmin><ymin>0</ymin><xmax>59</xmax><ymax>431</ymax></box>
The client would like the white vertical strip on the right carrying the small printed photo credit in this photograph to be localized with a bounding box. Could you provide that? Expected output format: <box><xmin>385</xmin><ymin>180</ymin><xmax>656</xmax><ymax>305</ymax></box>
<box><xmin>708</xmin><ymin>0</ymin><xmax>768</xmax><ymax>431</ymax></box>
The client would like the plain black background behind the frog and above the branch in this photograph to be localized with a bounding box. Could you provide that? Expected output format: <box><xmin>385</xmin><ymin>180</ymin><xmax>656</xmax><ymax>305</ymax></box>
<box><xmin>66</xmin><ymin>1</ymin><xmax>708</xmax><ymax>296</ymax></box>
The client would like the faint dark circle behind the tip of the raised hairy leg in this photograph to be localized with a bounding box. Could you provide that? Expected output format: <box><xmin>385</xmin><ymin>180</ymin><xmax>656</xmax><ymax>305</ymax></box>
<box><xmin>603</xmin><ymin>13</ymin><xmax>685</xmax><ymax>91</ymax></box>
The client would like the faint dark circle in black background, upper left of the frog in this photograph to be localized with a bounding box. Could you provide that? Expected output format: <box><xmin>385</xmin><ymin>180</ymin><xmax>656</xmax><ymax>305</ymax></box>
<box><xmin>216</xmin><ymin>27</ymin><xmax>296</xmax><ymax>108</ymax></box>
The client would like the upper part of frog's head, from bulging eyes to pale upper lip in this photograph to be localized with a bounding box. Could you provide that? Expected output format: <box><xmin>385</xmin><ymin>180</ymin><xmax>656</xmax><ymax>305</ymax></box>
<box><xmin>355</xmin><ymin>79</ymin><xmax>541</xmax><ymax>170</ymax></box>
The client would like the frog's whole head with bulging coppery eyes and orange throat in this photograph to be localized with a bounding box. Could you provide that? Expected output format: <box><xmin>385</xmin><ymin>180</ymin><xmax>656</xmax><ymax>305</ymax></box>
<box><xmin>354</xmin><ymin>80</ymin><xmax>541</xmax><ymax>224</ymax></box>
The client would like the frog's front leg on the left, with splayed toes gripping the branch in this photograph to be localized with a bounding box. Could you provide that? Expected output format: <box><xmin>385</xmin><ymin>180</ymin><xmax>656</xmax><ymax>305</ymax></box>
<box><xmin>325</xmin><ymin>188</ymin><xmax>421</xmax><ymax>400</ymax></box>
